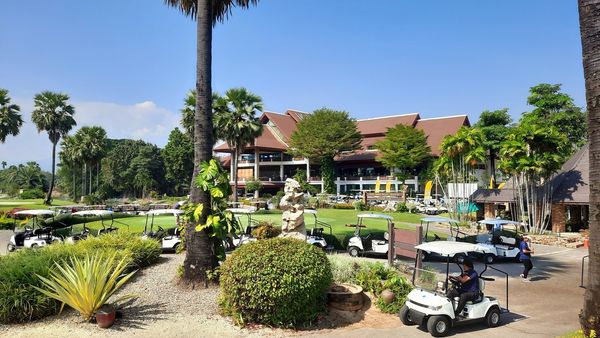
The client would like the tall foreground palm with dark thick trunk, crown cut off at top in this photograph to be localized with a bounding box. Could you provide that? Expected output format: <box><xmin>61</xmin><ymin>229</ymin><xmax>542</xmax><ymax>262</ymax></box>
<box><xmin>165</xmin><ymin>0</ymin><xmax>258</xmax><ymax>285</ymax></box>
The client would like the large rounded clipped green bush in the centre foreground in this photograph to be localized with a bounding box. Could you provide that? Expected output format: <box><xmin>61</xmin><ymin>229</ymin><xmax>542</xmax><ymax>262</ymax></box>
<box><xmin>219</xmin><ymin>238</ymin><xmax>332</xmax><ymax>327</ymax></box>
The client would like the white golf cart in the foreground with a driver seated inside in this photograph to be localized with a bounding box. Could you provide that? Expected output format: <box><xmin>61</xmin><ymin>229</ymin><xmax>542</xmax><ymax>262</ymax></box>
<box><xmin>399</xmin><ymin>241</ymin><xmax>508</xmax><ymax>337</ymax></box>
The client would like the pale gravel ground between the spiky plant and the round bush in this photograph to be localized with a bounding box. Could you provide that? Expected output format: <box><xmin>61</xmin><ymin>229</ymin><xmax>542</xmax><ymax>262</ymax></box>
<box><xmin>0</xmin><ymin>255</ymin><xmax>284</xmax><ymax>338</ymax></box>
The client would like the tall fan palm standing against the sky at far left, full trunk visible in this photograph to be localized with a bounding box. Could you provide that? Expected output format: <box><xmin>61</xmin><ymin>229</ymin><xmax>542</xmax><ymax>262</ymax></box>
<box><xmin>31</xmin><ymin>91</ymin><xmax>77</xmax><ymax>204</ymax></box>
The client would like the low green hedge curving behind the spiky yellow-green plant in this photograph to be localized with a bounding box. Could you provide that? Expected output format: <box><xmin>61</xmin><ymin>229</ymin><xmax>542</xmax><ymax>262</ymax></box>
<box><xmin>0</xmin><ymin>233</ymin><xmax>161</xmax><ymax>323</ymax></box>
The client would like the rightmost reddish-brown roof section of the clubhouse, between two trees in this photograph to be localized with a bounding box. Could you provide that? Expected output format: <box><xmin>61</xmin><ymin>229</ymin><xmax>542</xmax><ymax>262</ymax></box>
<box><xmin>415</xmin><ymin>115</ymin><xmax>471</xmax><ymax>156</ymax></box>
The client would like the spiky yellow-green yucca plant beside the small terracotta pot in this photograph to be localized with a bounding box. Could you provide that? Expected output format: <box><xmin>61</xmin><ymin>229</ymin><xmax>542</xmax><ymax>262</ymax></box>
<box><xmin>35</xmin><ymin>254</ymin><xmax>136</xmax><ymax>320</ymax></box>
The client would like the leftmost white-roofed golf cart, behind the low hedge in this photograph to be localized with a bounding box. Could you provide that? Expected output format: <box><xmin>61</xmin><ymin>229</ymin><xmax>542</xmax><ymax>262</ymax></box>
<box><xmin>6</xmin><ymin>209</ymin><xmax>62</xmax><ymax>252</ymax></box>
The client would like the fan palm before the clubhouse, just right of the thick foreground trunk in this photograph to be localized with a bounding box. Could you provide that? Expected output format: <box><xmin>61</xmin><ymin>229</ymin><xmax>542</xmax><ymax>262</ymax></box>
<box><xmin>213</xmin><ymin>88</ymin><xmax>263</xmax><ymax>202</ymax></box>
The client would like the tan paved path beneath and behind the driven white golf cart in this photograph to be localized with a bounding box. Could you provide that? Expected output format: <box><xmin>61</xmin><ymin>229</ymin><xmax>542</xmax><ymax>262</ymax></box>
<box><xmin>311</xmin><ymin>245</ymin><xmax>587</xmax><ymax>338</ymax></box>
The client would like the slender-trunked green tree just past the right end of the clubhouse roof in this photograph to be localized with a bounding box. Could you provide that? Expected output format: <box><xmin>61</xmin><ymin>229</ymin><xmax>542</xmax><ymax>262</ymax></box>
<box><xmin>474</xmin><ymin>108</ymin><xmax>512</xmax><ymax>182</ymax></box>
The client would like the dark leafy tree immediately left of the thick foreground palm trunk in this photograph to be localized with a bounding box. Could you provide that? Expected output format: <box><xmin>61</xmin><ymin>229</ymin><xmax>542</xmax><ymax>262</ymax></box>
<box><xmin>162</xmin><ymin>128</ymin><xmax>194</xmax><ymax>195</ymax></box>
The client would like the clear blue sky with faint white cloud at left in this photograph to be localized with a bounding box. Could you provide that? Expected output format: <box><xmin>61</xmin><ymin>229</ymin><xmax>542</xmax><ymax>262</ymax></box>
<box><xmin>0</xmin><ymin>0</ymin><xmax>585</xmax><ymax>168</ymax></box>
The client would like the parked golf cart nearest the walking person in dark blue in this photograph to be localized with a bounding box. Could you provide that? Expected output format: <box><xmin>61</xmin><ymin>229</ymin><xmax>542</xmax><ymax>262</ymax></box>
<box><xmin>476</xmin><ymin>219</ymin><xmax>520</xmax><ymax>264</ymax></box>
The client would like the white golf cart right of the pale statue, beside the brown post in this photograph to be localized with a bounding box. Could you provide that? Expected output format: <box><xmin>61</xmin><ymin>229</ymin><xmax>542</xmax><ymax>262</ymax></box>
<box><xmin>348</xmin><ymin>214</ymin><xmax>394</xmax><ymax>257</ymax></box>
